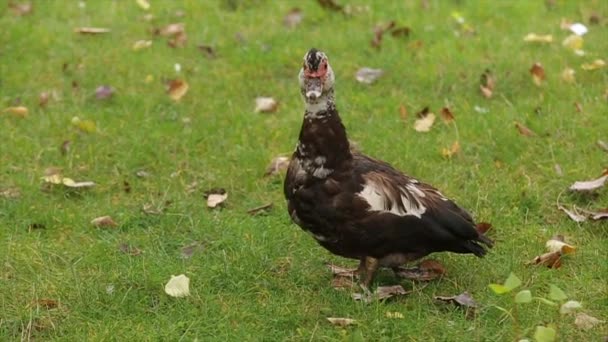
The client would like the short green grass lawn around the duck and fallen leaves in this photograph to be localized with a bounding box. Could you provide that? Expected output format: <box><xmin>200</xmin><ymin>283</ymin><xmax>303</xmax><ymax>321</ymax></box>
<box><xmin>0</xmin><ymin>0</ymin><xmax>608</xmax><ymax>341</ymax></box>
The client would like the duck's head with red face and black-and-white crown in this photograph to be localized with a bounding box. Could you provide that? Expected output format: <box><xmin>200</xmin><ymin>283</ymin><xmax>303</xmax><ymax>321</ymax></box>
<box><xmin>299</xmin><ymin>48</ymin><xmax>335</xmax><ymax>103</ymax></box>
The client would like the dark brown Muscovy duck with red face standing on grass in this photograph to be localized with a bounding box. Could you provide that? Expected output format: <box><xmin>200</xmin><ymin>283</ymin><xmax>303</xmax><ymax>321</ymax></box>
<box><xmin>283</xmin><ymin>48</ymin><xmax>493</xmax><ymax>289</ymax></box>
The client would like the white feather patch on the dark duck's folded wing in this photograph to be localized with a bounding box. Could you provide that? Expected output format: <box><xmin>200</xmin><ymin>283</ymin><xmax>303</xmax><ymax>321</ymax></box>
<box><xmin>357</xmin><ymin>180</ymin><xmax>426</xmax><ymax>218</ymax></box>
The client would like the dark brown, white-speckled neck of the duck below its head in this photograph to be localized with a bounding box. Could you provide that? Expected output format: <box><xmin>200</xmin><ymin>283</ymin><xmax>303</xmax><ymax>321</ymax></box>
<box><xmin>294</xmin><ymin>90</ymin><xmax>352</xmax><ymax>178</ymax></box>
